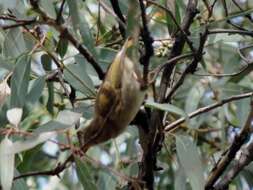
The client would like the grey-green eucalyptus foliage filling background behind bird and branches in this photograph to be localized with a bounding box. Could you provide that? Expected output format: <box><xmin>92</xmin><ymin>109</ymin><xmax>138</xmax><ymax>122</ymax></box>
<box><xmin>0</xmin><ymin>0</ymin><xmax>253</xmax><ymax>190</ymax></box>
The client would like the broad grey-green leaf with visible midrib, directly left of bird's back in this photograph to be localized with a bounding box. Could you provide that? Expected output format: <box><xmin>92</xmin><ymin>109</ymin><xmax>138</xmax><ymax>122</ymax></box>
<box><xmin>63</xmin><ymin>60</ymin><xmax>95</xmax><ymax>95</ymax></box>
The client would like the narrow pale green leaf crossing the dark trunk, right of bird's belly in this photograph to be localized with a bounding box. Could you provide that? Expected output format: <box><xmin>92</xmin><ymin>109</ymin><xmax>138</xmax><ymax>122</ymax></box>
<box><xmin>145</xmin><ymin>100</ymin><xmax>185</xmax><ymax>116</ymax></box>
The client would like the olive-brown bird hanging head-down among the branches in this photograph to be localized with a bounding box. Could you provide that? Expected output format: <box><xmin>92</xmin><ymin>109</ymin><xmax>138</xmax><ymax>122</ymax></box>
<box><xmin>77</xmin><ymin>37</ymin><xmax>146</xmax><ymax>153</ymax></box>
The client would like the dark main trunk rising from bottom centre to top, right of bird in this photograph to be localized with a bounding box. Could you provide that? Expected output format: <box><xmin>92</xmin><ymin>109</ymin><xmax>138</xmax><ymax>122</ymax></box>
<box><xmin>135</xmin><ymin>0</ymin><xmax>197</xmax><ymax>190</ymax></box>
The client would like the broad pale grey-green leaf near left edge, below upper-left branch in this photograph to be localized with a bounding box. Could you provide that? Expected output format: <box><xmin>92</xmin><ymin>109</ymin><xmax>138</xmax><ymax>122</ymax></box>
<box><xmin>3</xmin><ymin>28</ymin><xmax>26</xmax><ymax>58</ymax></box>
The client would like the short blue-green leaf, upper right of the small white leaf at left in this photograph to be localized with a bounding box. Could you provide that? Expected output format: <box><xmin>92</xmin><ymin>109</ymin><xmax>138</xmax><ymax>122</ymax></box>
<box><xmin>26</xmin><ymin>77</ymin><xmax>45</xmax><ymax>103</ymax></box>
